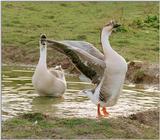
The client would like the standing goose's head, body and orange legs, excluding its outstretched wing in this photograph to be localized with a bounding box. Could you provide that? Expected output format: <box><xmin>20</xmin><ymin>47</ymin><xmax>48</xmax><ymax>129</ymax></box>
<box><xmin>83</xmin><ymin>21</ymin><xmax>127</xmax><ymax>117</ymax></box>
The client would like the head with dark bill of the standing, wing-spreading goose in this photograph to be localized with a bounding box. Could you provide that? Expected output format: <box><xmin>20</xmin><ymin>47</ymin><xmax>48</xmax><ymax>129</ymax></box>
<box><xmin>102</xmin><ymin>20</ymin><xmax>120</xmax><ymax>35</ymax></box>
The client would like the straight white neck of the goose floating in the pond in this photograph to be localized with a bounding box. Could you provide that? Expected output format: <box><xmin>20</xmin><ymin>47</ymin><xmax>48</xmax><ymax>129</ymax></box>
<box><xmin>38</xmin><ymin>47</ymin><xmax>47</xmax><ymax>68</ymax></box>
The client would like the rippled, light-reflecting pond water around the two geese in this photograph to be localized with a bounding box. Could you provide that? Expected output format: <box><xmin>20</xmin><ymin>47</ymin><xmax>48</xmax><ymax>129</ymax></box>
<box><xmin>2</xmin><ymin>66</ymin><xmax>160</xmax><ymax>121</ymax></box>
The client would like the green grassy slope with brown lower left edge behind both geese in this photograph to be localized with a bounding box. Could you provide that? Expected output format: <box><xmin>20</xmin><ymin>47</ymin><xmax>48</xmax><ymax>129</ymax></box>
<box><xmin>2</xmin><ymin>2</ymin><xmax>159</xmax><ymax>65</ymax></box>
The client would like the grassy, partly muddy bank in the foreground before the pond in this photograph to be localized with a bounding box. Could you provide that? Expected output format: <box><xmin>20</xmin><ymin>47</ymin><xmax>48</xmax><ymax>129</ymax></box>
<box><xmin>2</xmin><ymin>110</ymin><xmax>159</xmax><ymax>139</ymax></box>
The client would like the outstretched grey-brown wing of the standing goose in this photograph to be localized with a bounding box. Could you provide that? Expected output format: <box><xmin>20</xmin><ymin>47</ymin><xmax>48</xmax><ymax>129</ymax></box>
<box><xmin>46</xmin><ymin>39</ymin><xmax>106</xmax><ymax>84</ymax></box>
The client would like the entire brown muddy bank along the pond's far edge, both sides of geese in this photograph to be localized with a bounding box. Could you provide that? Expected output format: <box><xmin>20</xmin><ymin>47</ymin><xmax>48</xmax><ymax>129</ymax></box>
<box><xmin>2</xmin><ymin>46</ymin><xmax>159</xmax><ymax>84</ymax></box>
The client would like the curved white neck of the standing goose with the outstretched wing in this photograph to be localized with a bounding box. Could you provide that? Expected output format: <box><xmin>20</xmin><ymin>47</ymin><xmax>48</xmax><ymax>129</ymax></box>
<box><xmin>101</xmin><ymin>29</ymin><xmax>113</xmax><ymax>58</ymax></box>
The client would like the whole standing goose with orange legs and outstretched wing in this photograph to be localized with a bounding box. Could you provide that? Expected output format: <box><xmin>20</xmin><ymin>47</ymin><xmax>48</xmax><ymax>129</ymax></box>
<box><xmin>42</xmin><ymin>21</ymin><xmax>127</xmax><ymax>117</ymax></box>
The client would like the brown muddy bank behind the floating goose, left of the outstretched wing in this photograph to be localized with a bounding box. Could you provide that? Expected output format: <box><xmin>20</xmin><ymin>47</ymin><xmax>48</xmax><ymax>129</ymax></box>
<box><xmin>2</xmin><ymin>46</ymin><xmax>79</xmax><ymax>73</ymax></box>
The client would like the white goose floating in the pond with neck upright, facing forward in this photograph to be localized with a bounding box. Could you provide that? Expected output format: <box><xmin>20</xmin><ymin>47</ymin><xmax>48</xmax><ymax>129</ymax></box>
<box><xmin>32</xmin><ymin>35</ymin><xmax>66</xmax><ymax>97</ymax></box>
